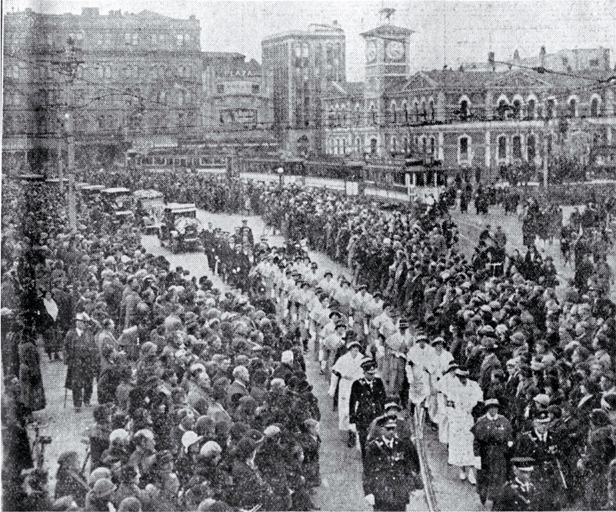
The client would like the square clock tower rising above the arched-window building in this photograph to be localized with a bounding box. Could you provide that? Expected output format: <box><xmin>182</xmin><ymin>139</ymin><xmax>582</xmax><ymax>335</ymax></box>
<box><xmin>361</xmin><ymin>18</ymin><xmax>415</xmax><ymax>125</ymax></box>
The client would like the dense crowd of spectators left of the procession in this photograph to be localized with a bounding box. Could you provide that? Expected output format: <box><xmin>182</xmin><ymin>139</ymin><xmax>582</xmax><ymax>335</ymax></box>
<box><xmin>2</xmin><ymin>177</ymin><xmax>328</xmax><ymax>511</ymax></box>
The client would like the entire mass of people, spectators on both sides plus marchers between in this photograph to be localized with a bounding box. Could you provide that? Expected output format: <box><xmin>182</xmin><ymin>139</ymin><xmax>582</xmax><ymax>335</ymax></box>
<box><xmin>2</xmin><ymin>165</ymin><xmax>616</xmax><ymax>510</ymax></box>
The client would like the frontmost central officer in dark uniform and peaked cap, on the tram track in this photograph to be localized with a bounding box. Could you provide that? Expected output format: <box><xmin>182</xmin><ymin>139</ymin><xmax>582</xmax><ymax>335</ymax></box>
<box><xmin>363</xmin><ymin>416</ymin><xmax>422</xmax><ymax>510</ymax></box>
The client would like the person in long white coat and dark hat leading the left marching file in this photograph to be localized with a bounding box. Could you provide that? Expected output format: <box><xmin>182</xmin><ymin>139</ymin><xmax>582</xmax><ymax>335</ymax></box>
<box><xmin>327</xmin><ymin>338</ymin><xmax>365</xmax><ymax>447</ymax></box>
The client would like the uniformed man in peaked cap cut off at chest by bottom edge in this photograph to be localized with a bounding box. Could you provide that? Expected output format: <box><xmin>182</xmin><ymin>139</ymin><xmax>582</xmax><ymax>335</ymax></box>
<box><xmin>492</xmin><ymin>457</ymin><xmax>541</xmax><ymax>510</ymax></box>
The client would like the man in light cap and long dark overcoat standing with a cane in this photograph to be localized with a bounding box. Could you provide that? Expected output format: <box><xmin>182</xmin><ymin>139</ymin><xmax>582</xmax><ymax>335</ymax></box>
<box><xmin>64</xmin><ymin>313</ymin><xmax>99</xmax><ymax>412</ymax></box>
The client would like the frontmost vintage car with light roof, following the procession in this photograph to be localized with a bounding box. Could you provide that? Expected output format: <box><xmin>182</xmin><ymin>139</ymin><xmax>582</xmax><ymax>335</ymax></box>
<box><xmin>158</xmin><ymin>203</ymin><xmax>202</xmax><ymax>253</ymax></box>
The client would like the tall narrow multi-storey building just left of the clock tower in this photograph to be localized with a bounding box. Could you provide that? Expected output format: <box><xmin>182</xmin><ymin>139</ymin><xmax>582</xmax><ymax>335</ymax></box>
<box><xmin>262</xmin><ymin>22</ymin><xmax>346</xmax><ymax>154</ymax></box>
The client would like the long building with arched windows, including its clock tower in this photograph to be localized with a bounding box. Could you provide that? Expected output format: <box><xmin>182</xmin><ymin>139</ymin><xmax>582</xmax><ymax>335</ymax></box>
<box><xmin>324</xmin><ymin>20</ymin><xmax>616</xmax><ymax>184</ymax></box>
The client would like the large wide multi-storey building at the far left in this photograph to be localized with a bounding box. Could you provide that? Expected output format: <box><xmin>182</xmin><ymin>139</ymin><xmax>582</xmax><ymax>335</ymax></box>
<box><xmin>3</xmin><ymin>8</ymin><xmax>202</xmax><ymax>170</ymax></box>
